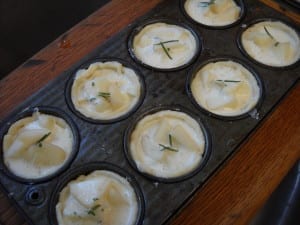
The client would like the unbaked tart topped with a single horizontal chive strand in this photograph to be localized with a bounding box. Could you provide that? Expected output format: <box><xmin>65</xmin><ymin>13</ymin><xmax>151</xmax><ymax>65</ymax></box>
<box><xmin>191</xmin><ymin>61</ymin><xmax>260</xmax><ymax>116</ymax></box>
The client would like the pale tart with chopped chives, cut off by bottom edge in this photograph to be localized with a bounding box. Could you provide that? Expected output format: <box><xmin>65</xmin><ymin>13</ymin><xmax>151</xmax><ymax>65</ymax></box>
<box><xmin>56</xmin><ymin>170</ymin><xmax>138</xmax><ymax>225</ymax></box>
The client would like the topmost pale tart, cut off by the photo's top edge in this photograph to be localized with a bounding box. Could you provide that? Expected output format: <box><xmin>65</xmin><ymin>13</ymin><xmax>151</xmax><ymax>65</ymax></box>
<box><xmin>184</xmin><ymin>0</ymin><xmax>241</xmax><ymax>26</ymax></box>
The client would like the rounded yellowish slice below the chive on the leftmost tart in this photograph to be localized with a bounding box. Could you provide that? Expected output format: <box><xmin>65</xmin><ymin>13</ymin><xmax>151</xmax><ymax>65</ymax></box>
<box><xmin>23</xmin><ymin>142</ymin><xmax>66</xmax><ymax>167</ymax></box>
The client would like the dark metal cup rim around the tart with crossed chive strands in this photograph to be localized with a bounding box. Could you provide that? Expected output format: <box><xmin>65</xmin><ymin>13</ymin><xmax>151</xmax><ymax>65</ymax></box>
<box><xmin>127</xmin><ymin>17</ymin><xmax>203</xmax><ymax>72</ymax></box>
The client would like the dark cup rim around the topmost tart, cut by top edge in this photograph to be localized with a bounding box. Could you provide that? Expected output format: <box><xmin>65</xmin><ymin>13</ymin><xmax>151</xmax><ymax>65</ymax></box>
<box><xmin>180</xmin><ymin>0</ymin><xmax>246</xmax><ymax>30</ymax></box>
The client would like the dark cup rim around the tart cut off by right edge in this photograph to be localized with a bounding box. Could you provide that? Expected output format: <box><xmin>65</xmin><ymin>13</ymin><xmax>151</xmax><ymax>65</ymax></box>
<box><xmin>236</xmin><ymin>18</ymin><xmax>300</xmax><ymax>70</ymax></box>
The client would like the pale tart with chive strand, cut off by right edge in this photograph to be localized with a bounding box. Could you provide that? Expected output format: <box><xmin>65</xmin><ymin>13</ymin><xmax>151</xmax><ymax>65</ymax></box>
<box><xmin>241</xmin><ymin>21</ymin><xmax>300</xmax><ymax>67</ymax></box>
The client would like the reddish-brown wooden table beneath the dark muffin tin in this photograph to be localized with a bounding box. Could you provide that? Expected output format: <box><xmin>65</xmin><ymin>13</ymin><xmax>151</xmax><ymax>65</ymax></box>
<box><xmin>0</xmin><ymin>0</ymin><xmax>300</xmax><ymax>225</ymax></box>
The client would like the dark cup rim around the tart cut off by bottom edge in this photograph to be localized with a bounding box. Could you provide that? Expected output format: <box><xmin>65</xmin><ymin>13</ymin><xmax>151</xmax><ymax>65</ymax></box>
<box><xmin>48</xmin><ymin>162</ymin><xmax>145</xmax><ymax>225</ymax></box>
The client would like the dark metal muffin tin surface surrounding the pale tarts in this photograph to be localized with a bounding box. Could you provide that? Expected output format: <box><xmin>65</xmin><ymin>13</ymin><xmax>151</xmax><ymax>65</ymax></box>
<box><xmin>0</xmin><ymin>0</ymin><xmax>300</xmax><ymax>225</ymax></box>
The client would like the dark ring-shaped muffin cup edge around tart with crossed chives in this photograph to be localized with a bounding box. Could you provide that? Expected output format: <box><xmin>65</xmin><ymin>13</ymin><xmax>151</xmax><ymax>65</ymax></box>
<box><xmin>127</xmin><ymin>18</ymin><xmax>202</xmax><ymax>72</ymax></box>
